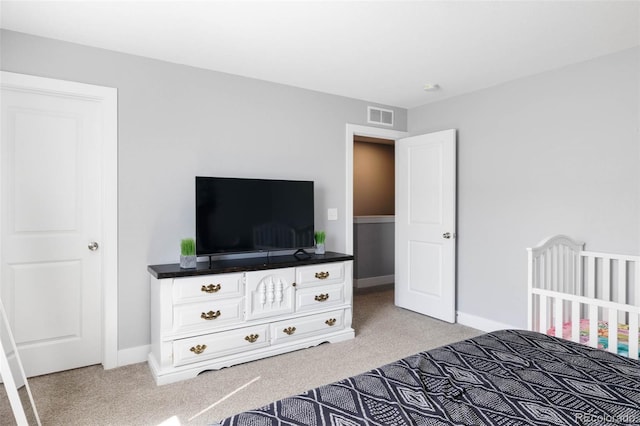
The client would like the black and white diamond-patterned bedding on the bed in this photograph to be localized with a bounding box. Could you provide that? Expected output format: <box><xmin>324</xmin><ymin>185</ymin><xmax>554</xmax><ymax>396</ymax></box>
<box><xmin>218</xmin><ymin>330</ymin><xmax>640</xmax><ymax>426</ymax></box>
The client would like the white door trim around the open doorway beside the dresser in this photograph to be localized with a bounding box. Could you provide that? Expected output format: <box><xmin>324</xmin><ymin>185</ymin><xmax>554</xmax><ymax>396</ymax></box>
<box><xmin>344</xmin><ymin>123</ymin><xmax>409</xmax><ymax>255</ymax></box>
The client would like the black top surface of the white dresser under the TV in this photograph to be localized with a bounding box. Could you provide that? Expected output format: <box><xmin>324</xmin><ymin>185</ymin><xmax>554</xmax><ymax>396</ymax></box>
<box><xmin>147</xmin><ymin>251</ymin><xmax>353</xmax><ymax>279</ymax></box>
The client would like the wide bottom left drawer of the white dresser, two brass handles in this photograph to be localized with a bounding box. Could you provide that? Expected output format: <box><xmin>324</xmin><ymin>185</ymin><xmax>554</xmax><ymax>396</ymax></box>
<box><xmin>173</xmin><ymin>324</ymin><xmax>270</xmax><ymax>366</ymax></box>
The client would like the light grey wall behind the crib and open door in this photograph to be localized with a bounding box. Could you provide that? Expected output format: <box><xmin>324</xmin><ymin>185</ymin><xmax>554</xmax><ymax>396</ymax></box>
<box><xmin>409</xmin><ymin>48</ymin><xmax>640</xmax><ymax>327</ymax></box>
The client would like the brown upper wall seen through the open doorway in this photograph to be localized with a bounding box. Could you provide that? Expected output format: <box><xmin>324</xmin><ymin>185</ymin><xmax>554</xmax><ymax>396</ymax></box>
<box><xmin>353</xmin><ymin>141</ymin><xmax>395</xmax><ymax>216</ymax></box>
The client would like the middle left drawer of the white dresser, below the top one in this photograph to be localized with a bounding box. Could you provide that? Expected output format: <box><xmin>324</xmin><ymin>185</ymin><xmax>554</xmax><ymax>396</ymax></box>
<box><xmin>173</xmin><ymin>297</ymin><xmax>244</xmax><ymax>332</ymax></box>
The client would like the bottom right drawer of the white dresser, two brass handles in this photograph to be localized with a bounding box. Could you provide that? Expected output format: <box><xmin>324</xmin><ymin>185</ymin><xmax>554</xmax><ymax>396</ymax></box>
<box><xmin>271</xmin><ymin>310</ymin><xmax>344</xmax><ymax>344</ymax></box>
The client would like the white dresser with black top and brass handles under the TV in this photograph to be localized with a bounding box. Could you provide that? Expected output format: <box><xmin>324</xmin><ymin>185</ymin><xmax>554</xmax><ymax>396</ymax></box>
<box><xmin>148</xmin><ymin>252</ymin><xmax>354</xmax><ymax>385</ymax></box>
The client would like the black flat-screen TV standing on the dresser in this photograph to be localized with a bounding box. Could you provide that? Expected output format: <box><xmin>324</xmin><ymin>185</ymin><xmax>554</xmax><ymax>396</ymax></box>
<box><xmin>196</xmin><ymin>176</ymin><xmax>314</xmax><ymax>256</ymax></box>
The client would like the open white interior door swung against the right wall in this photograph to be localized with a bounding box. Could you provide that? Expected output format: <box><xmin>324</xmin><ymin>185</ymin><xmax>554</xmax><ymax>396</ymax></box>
<box><xmin>395</xmin><ymin>130</ymin><xmax>456</xmax><ymax>322</ymax></box>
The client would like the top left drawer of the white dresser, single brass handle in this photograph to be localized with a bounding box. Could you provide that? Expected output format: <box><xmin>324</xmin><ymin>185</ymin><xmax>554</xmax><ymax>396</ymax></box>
<box><xmin>173</xmin><ymin>273</ymin><xmax>244</xmax><ymax>303</ymax></box>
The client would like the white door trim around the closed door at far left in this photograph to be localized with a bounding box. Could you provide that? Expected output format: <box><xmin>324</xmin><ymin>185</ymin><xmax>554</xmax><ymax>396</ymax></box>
<box><xmin>0</xmin><ymin>71</ymin><xmax>118</xmax><ymax>369</ymax></box>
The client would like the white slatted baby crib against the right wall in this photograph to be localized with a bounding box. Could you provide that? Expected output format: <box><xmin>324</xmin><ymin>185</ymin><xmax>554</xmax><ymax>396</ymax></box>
<box><xmin>527</xmin><ymin>235</ymin><xmax>640</xmax><ymax>359</ymax></box>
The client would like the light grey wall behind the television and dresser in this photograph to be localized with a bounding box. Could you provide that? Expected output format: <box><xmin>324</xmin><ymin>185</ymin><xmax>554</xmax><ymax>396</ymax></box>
<box><xmin>0</xmin><ymin>30</ymin><xmax>407</xmax><ymax>350</ymax></box>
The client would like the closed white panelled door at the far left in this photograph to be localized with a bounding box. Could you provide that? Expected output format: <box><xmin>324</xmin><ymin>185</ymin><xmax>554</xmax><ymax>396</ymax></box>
<box><xmin>0</xmin><ymin>73</ymin><xmax>115</xmax><ymax>377</ymax></box>
